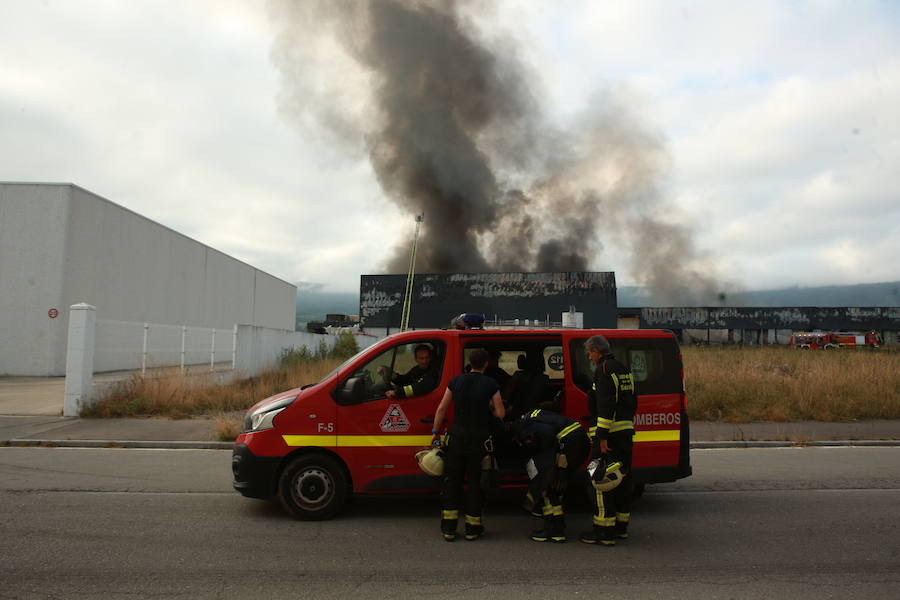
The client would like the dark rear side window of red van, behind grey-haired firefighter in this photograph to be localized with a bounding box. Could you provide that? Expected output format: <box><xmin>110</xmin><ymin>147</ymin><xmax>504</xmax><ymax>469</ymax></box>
<box><xmin>569</xmin><ymin>338</ymin><xmax>682</xmax><ymax>394</ymax></box>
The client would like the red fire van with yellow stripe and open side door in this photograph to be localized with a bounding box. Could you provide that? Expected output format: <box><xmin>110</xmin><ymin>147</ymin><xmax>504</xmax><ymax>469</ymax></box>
<box><xmin>232</xmin><ymin>329</ymin><xmax>691</xmax><ymax>520</ymax></box>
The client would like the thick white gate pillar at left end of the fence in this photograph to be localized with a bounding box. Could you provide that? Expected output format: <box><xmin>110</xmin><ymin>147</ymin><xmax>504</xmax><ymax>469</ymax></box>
<box><xmin>63</xmin><ymin>303</ymin><xmax>97</xmax><ymax>417</ymax></box>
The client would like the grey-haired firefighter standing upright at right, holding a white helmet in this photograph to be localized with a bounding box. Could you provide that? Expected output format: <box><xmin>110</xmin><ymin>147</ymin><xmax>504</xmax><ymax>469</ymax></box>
<box><xmin>579</xmin><ymin>335</ymin><xmax>637</xmax><ymax>546</ymax></box>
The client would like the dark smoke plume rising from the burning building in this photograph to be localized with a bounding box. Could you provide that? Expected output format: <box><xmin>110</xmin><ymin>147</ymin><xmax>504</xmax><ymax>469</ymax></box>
<box><xmin>270</xmin><ymin>0</ymin><xmax>719</xmax><ymax>302</ymax></box>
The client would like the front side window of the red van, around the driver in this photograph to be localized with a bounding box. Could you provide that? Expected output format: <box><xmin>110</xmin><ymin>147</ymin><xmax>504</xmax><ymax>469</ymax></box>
<box><xmin>335</xmin><ymin>340</ymin><xmax>445</xmax><ymax>405</ymax></box>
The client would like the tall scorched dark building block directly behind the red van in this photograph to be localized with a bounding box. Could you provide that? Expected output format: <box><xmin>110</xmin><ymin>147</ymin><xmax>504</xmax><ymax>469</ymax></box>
<box><xmin>359</xmin><ymin>272</ymin><xmax>616</xmax><ymax>330</ymax></box>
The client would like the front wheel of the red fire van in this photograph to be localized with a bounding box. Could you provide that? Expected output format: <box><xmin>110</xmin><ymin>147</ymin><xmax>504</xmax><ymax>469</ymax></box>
<box><xmin>278</xmin><ymin>454</ymin><xmax>347</xmax><ymax>521</ymax></box>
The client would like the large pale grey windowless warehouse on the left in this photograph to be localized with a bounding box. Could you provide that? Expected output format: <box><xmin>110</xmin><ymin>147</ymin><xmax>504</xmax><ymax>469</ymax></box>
<box><xmin>0</xmin><ymin>183</ymin><xmax>297</xmax><ymax>376</ymax></box>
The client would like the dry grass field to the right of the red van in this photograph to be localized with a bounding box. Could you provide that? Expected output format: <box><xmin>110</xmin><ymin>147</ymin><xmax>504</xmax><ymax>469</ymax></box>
<box><xmin>683</xmin><ymin>347</ymin><xmax>900</xmax><ymax>423</ymax></box>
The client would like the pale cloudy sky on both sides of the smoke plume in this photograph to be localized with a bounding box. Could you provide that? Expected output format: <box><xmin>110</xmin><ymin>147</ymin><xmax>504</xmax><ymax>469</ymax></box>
<box><xmin>0</xmin><ymin>0</ymin><xmax>900</xmax><ymax>291</ymax></box>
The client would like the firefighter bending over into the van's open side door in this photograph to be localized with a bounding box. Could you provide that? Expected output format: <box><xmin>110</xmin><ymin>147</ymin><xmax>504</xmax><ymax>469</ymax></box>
<box><xmin>514</xmin><ymin>408</ymin><xmax>591</xmax><ymax>543</ymax></box>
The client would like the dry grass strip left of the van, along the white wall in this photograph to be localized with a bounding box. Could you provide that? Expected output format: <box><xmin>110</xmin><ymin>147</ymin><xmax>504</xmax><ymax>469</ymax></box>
<box><xmin>82</xmin><ymin>358</ymin><xmax>343</xmax><ymax>420</ymax></box>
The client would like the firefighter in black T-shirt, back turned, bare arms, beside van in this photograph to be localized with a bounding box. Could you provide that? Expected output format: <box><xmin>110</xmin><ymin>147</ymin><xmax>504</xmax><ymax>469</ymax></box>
<box><xmin>431</xmin><ymin>349</ymin><xmax>506</xmax><ymax>542</ymax></box>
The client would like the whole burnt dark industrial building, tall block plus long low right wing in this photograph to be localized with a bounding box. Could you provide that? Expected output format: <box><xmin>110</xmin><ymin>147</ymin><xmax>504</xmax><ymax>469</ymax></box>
<box><xmin>359</xmin><ymin>272</ymin><xmax>900</xmax><ymax>345</ymax></box>
